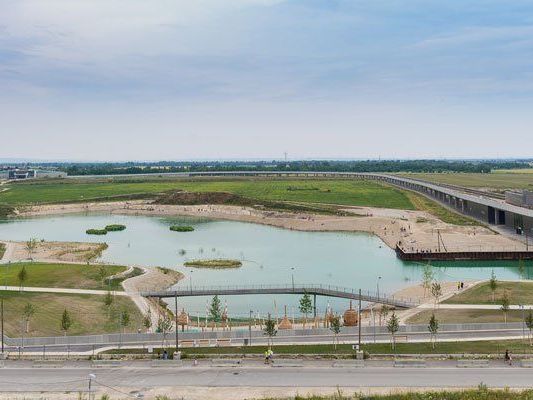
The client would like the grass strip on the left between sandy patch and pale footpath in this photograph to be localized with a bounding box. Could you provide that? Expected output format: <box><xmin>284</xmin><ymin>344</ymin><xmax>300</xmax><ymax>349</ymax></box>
<box><xmin>0</xmin><ymin>262</ymin><xmax>126</xmax><ymax>290</ymax></box>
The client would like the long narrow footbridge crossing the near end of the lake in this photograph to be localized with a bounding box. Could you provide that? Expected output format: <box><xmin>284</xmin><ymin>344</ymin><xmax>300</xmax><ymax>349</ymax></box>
<box><xmin>141</xmin><ymin>284</ymin><xmax>420</xmax><ymax>310</ymax></box>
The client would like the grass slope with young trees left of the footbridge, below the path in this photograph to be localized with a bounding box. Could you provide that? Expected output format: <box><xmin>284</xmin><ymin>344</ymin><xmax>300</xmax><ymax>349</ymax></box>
<box><xmin>0</xmin><ymin>291</ymin><xmax>142</xmax><ymax>337</ymax></box>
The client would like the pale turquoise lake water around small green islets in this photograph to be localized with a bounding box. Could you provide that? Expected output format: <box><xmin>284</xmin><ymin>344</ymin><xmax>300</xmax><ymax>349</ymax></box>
<box><xmin>0</xmin><ymin>214</ymin><xmax>533</xmax><ymax>316</ymax></box>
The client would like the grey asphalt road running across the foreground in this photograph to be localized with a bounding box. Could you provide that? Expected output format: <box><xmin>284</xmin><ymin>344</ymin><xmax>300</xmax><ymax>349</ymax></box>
<box><xmin>0</xmin><ymin>362</ymin><xmax>533</xmax><ymax>392</ymax></box>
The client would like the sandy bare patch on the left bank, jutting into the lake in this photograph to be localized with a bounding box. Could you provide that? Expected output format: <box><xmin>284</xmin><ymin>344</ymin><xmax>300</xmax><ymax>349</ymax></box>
<box><xmin>2</xmin><ymin>241</ymin><xmax>107</xmax><ymax>263</ymax></box>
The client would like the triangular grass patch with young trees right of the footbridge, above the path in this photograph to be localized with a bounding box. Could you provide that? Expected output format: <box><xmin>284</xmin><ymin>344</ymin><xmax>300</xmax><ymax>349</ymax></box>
<box><xmin>443</xmin><ymin>281</ymin><xmax>533</xmax><ymax>304</ymax></box>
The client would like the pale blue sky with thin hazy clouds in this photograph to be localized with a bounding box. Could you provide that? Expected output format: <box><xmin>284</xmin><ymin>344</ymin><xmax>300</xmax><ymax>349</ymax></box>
<box><xmin>0</xmin><ymin>0</ymin><xmax>533</xmax><ymax>161</ymax></box>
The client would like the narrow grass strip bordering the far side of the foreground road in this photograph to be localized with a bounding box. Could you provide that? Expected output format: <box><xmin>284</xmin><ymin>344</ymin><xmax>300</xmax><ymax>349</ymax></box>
<box><xmin>106</xmin><ymin>338</ymin><xmax>533</xmax><ymax>357</ymax></box>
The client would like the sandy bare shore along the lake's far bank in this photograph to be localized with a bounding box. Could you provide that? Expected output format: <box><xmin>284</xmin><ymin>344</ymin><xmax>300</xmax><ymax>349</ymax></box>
<box><xmin>20</xmin><ymin>201</ymin><xmax>525</xmax><ymax>251</ymax></box>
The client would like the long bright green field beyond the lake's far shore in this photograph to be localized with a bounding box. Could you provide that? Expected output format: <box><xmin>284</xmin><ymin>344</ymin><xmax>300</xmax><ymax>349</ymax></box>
<box><xmin>0</xmin><ymin>179</ymin><xmax>414</xmax><ymax>210</ymax></box>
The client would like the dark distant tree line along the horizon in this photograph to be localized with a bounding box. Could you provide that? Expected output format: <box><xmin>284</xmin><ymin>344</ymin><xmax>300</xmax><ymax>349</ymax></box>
<box><xmin>14</xmin><ymin>160</ymin><xmax>532</xmax><ymax>175</ymax></box>
